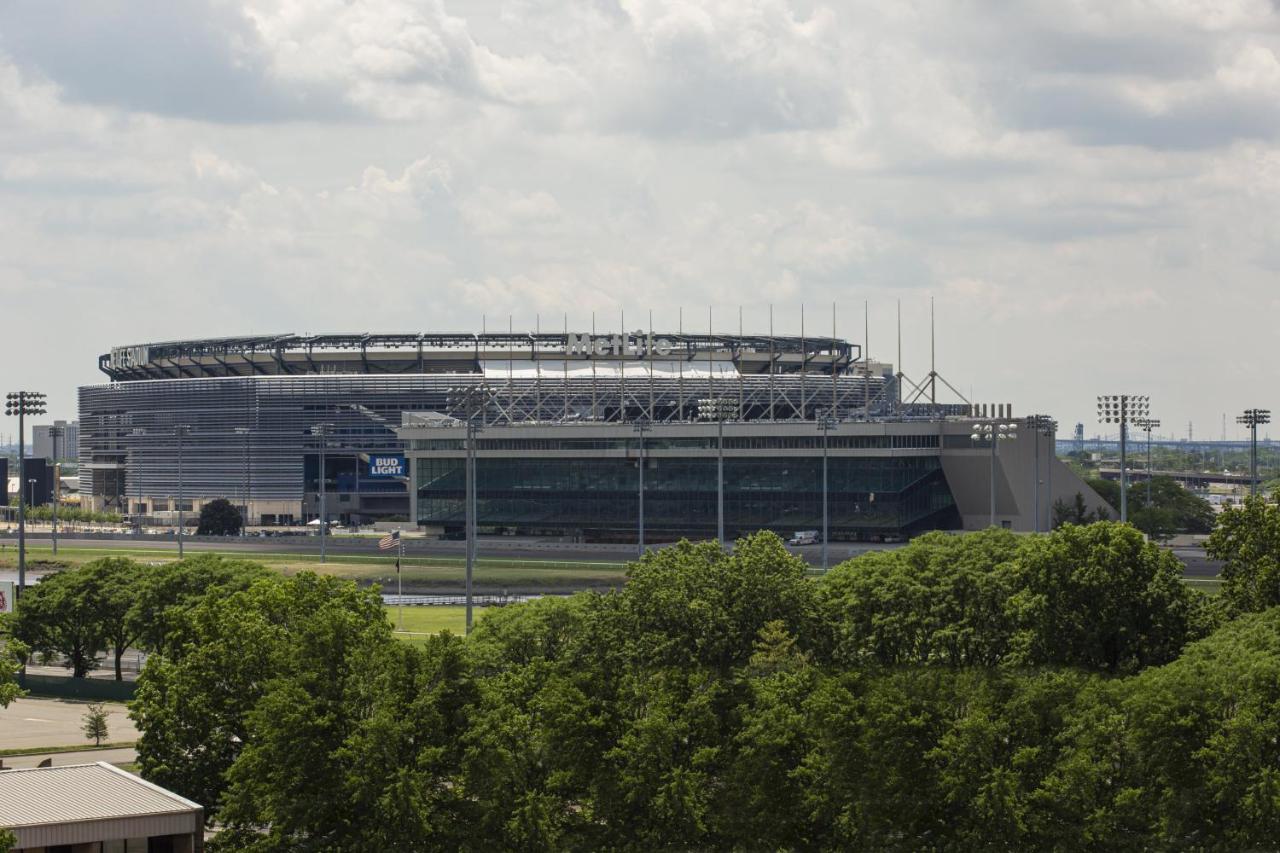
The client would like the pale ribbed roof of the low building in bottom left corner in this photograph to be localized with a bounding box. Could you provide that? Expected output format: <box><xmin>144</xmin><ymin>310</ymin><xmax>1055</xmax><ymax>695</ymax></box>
<box><xmin>0</xmin><ymin>761</ymin><xmax>201</xmax><ymax>829</ymax></box>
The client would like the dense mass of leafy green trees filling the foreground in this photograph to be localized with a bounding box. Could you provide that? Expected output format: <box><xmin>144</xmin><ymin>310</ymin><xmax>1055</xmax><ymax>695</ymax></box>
<box><xmin>7</xmin><ymin>501</ymin><xmax>1280</xmax><ymax>850</ymax></box>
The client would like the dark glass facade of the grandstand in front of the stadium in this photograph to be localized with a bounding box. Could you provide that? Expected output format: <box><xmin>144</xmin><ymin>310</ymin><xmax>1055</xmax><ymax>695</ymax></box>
<box><xmin>416</xmin><ymin>450</ymin><xmax>960</xmax><ymax>542</ymax></box>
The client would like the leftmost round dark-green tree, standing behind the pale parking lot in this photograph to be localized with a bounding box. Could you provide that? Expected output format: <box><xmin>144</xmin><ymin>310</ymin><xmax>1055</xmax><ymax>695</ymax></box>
<box><xmin>13</xmin><ymin>569</ymin><xmax>106</xmax><ymax>678</ymax></box>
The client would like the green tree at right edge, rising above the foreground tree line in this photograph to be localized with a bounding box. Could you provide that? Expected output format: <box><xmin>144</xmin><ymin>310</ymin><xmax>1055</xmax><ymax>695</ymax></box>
<box><xmin>1204</xmin><ymin>492</ymin><xmax>1280</xmax><ymax>611</ymax></box>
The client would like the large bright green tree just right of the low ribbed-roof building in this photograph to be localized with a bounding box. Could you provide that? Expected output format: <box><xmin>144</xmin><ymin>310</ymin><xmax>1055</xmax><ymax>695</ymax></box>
<box><xmin>129</xmin><ymin>573</ymin><xmax>393</xmax><ymax>818</ymax></box>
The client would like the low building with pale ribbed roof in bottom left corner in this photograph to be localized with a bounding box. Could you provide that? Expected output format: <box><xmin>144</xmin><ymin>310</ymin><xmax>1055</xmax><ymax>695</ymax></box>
<box><xmin>0</xmin><ymin>761</ymin><xmax>205</xmax><ymax>853</ymax></box>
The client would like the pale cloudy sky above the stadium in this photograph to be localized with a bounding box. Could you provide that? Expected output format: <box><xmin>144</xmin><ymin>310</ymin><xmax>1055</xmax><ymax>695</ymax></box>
<box><xmin>0</xmin><ymin>0</ymin><xmax>1280</xmax><ymax>438</ymax></box>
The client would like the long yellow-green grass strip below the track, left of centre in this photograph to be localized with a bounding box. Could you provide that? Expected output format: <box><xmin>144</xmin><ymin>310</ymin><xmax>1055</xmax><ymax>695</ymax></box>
<box><xmin>0</xmin><ymin>542</ymin><xmax>626</xmax><ymax>592</ymax></box>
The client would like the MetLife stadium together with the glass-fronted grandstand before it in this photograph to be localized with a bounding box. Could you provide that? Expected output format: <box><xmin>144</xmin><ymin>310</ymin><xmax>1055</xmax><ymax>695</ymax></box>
<box><xmin>79</xmin><ymin>330</ymin><xmax>1096</xmax><ymax>542</ymax></box>
